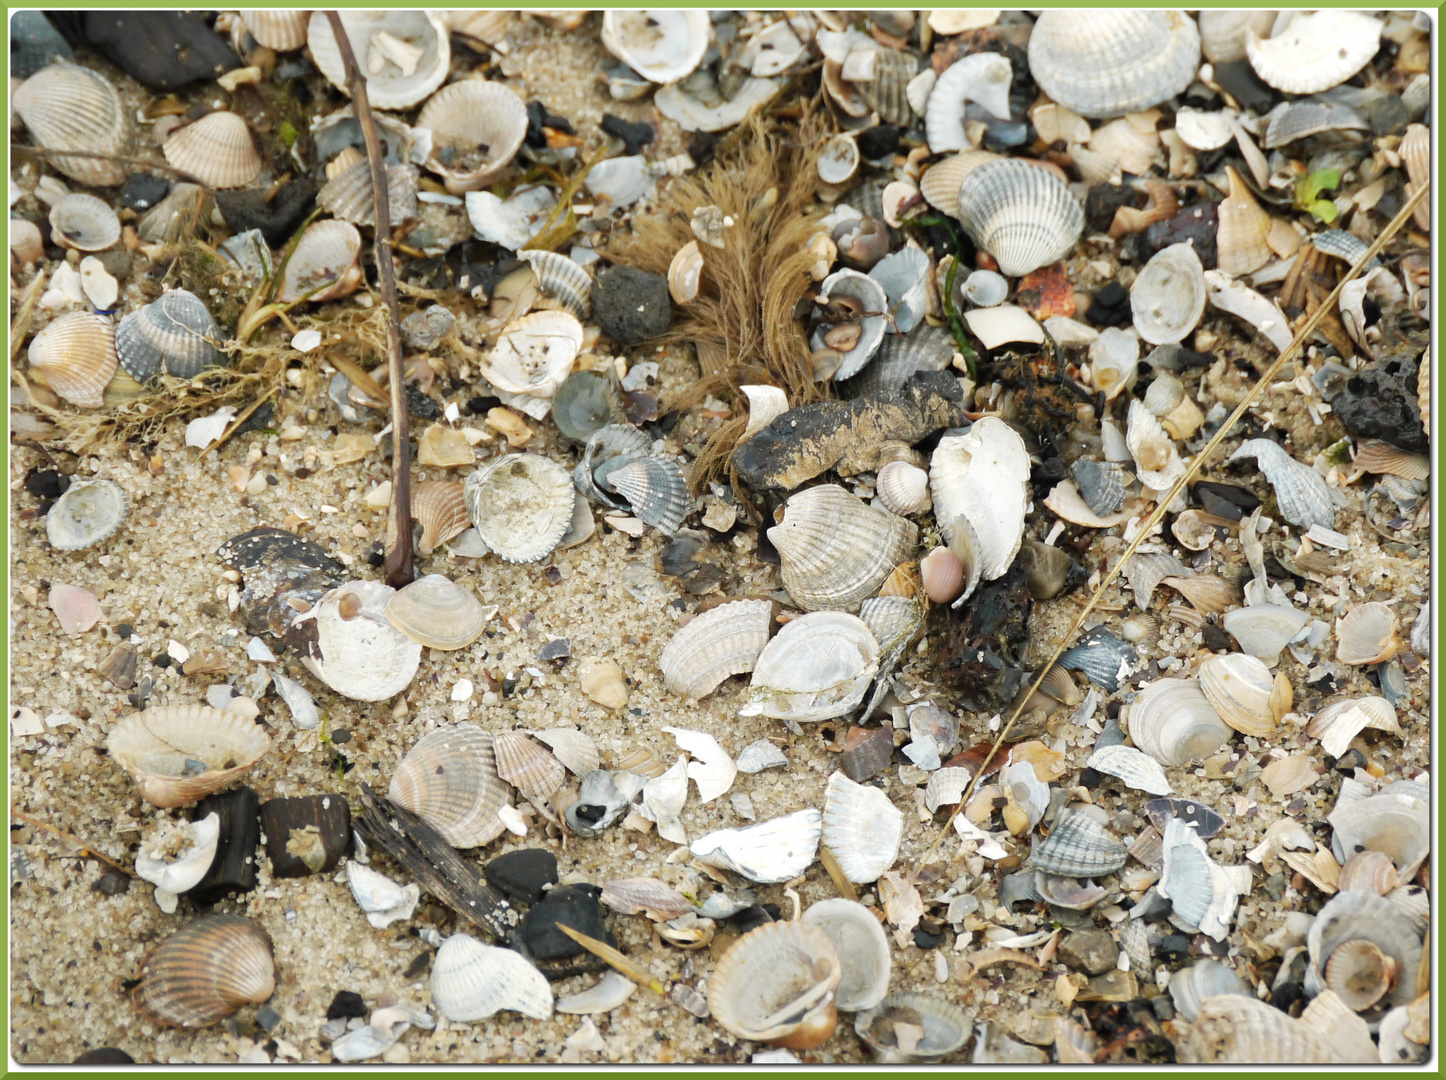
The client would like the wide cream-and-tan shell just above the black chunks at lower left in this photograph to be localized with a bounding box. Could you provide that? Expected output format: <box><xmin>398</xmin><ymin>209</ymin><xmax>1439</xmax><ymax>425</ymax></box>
<box><xmin>106</xmin><ymin>706</ymin><xmax>270</xmax><ymax>807</ymax></box>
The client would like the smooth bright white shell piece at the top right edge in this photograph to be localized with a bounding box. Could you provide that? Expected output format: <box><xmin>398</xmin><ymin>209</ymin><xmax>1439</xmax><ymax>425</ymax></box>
<box><xmin>1245</xmin><ymin>12</ymin><xmax>1381</xmax><ymax>94</ymax></box>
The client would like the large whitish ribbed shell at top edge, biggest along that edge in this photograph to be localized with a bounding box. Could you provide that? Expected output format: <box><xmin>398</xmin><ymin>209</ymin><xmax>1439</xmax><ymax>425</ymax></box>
<box><xmin>1030</xmin><ymin>9</ymin><xmax>1200</xmax><ymax>120</ymax></box>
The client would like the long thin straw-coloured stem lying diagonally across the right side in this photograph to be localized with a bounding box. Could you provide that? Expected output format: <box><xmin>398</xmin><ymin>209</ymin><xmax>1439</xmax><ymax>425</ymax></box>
<box><xmin>910</xmin><ymin>185</ymin><xmax>1427</xmax><ymax>883</ymax></box>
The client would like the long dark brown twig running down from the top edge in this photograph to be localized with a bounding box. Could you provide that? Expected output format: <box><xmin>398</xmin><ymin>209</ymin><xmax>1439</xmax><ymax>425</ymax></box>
<box><xmin>327</xmin><ymin>12</ymin><xmax>412</xmax><ymax>588</ymax></box>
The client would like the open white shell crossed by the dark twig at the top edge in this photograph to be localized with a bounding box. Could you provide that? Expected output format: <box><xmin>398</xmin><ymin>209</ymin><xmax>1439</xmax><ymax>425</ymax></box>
<box><xmin>307</xmin><ymin>9</ymin><xmax>451</xmax><ymax>110</ymax></box>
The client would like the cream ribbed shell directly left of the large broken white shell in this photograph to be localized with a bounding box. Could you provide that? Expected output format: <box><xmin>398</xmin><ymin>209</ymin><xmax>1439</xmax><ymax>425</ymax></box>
<box><xmin>768</xmin><ymin>484</ymin><xmax>918</xmax><ymax>612</ymax></box>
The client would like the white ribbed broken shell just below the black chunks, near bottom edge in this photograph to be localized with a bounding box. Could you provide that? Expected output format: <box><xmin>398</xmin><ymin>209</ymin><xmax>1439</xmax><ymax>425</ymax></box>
<box><xmin>428</xmin><ymin>934</ymin><xmax>552</xmax><ymax>1024</ymax></box>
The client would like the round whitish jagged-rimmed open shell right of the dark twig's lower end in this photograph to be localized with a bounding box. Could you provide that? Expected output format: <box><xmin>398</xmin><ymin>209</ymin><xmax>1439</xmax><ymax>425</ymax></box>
<box><xmin>463</xmin><ymin>451</ymin><xmax>575</xmax><ymax>562</ymax></box>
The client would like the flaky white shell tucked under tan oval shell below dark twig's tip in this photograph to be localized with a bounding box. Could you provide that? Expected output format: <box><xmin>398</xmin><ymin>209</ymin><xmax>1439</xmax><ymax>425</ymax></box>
<box><xmin>295</xmin><ymin>581</ymin><xmax>422</xmax><ymax>701</ymax></box>
